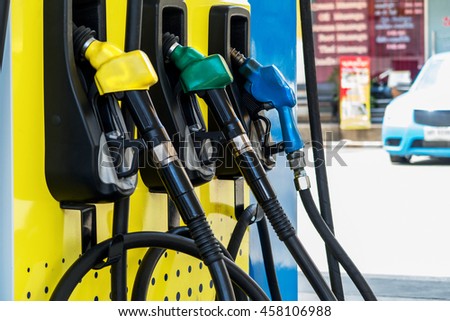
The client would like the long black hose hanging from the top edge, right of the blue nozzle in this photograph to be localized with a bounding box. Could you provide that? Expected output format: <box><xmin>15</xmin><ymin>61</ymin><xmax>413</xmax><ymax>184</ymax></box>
<box><xmin>299</xmin><ymin>0</ymin><xmax>345</xmax><ymax>301</ymax></box>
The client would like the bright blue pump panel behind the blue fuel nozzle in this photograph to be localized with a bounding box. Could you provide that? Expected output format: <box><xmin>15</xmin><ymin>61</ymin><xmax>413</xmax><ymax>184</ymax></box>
<box><xmin>249</xmin><ymin>0</ymin><xmax>298</xmax><ymax>301</ymax></box>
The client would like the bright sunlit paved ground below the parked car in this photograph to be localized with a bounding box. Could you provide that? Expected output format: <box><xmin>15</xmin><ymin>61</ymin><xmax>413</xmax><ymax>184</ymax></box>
<box><xmin>298</xmin><ymin>147</ymin><xmax>450</xmax><ymax>300</ymax></box>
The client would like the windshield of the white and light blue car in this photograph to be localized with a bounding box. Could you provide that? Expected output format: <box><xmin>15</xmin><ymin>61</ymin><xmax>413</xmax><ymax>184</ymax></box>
<box><xmin>413</xmin><ymin>56</ymin><xmax>450</xmax><ymax>90</ymax></box>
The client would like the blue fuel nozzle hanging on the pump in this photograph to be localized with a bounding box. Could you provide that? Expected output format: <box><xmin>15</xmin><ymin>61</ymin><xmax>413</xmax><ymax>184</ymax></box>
<box><xmin>230</xmin><ymin>49</ymin><xmax>304</xmax><ymax>154</ymax></box>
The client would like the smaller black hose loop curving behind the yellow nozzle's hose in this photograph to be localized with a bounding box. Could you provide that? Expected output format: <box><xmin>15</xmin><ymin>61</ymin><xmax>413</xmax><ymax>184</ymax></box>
<box><xmin>131</xmin><ymin>226</ymin><xmax>247</xmax><ymax>301</ymax></box>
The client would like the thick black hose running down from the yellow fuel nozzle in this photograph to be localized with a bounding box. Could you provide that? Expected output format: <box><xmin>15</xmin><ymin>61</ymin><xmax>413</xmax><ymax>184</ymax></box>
<box><xmin>122</xmin><ymin>90</ymin><xmax>235</xmax><ymax>301</ymax></box>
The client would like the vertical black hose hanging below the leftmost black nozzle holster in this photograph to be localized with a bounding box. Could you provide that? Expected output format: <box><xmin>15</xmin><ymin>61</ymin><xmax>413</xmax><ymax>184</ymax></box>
<box><xmin>111</xmin><ymin>197</ymin><xmax>130</xmax><ymax>301</ymax></box>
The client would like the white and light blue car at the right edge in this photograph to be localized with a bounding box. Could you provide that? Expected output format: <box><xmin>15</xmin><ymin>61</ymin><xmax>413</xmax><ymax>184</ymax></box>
<box><xmin>382</xmin><ymin>52</ymin><xmax>450</xmax><ymax>163</ymax></box>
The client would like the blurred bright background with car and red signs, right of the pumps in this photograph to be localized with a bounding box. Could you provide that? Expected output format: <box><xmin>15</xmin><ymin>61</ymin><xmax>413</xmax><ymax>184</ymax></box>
<box><xmin>297</xmin><ymin>0</ymin><xmax>450</xmax><ymax>300</ymax></box>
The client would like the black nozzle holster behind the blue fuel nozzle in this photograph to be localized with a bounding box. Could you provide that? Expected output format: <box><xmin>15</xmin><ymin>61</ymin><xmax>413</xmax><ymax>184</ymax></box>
<box><xmin>208</xmin><ymin>5</ymin><xmax>276</xmax><ymax>179</ymax></box>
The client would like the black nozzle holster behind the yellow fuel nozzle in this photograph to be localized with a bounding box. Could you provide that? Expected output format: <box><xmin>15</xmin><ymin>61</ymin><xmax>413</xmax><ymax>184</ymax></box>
<box><xmin>44</xmin><ymin>1</ymin><xmax>137</xmax><ymax>202</ymax></box>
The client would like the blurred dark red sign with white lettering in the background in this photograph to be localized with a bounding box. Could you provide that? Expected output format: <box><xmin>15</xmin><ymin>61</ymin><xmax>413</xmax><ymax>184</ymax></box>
<box><xmin>311</xmin><ymin>0</ymin><xmax>426</xmax><ymax>83</ymax></box>
